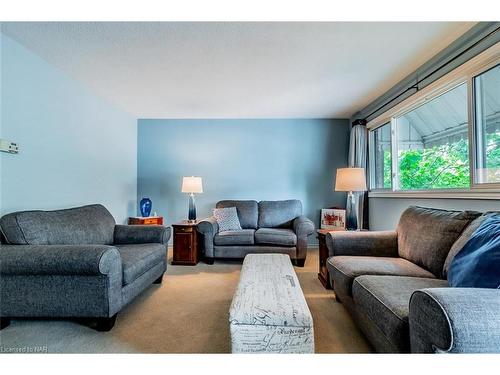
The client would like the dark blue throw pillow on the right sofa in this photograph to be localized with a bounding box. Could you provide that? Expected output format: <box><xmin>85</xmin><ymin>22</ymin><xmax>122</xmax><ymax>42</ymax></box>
<box><xmin>448</xmin><ymin>215</ymin><xmax>500</xmax><ymax>289</ymax></box>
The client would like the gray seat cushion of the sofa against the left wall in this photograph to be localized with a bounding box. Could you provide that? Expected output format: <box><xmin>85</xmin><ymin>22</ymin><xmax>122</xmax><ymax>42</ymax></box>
<box><xmin>115</xmin><ymin>243</ymin><xmax>167</xmax><ymax>285</ymax></box>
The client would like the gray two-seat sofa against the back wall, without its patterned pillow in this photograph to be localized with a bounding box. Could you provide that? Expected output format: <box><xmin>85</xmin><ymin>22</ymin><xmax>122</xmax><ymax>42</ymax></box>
<box><xmin>197</xmin><ymin>200</ymin><xmax>314</xmax><ymax>267</ymax></box>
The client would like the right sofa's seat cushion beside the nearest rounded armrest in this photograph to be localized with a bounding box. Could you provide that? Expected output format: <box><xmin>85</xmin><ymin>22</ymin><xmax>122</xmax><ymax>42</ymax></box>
<box><xmin>352</xmin><ymin>275</ymin><xmax>448</xmax><ymax>352</ymax></box>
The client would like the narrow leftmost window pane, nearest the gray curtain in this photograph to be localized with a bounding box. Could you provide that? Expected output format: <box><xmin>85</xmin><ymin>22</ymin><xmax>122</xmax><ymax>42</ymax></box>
<box><xmin>371</xmin><ymin>123</ymin><xmax>392</xmax><ymax>189</ymax></box>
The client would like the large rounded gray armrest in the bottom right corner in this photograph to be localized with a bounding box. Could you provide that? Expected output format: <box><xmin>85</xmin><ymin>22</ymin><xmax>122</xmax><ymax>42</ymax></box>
<box><xmin>409</xmin><ymin>288</ymin><xmax>500</xmax><ymax>353</ymax></box>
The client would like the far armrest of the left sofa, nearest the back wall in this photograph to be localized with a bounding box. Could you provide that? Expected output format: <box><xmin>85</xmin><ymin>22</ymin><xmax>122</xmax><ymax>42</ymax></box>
<box><xmin>114</xmin><ymin>225</ymin><xmax>170</xmax><ymax>245</ymax></box>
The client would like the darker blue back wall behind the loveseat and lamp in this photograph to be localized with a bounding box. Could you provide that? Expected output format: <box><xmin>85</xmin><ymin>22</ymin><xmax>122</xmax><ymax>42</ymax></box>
<box><xmin>137</xmin><ymin>119</ymin><xmax>349</xmax><ymax>241</ymax></box>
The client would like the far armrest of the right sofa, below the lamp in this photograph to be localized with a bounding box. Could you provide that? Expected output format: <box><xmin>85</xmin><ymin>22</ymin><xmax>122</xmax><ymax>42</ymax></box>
<box><xmin>326</xmin><ymin>231</ymin><xmax>398</xmax><ymax>257</ymax></box>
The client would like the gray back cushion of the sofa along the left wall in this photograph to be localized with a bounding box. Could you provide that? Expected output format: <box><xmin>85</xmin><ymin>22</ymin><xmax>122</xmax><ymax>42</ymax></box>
<box><xmin>0</xmin><ymin>204</ymin><xmax>115</xmax><ymax>245</ymax></box>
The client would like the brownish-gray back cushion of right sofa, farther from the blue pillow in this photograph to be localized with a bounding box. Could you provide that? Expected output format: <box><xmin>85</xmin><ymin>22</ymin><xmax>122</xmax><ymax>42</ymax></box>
<box><xmin>397</xmin><ymin>206</ymin><xmax>481</xmax><ymax>278</ymax></box>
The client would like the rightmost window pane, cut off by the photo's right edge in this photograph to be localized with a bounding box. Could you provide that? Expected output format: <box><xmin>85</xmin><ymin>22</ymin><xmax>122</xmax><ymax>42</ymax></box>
<box><xmin>474</xmin><ymin>65</ymin><xmax>500</xmax><ymax>184</ymax></box>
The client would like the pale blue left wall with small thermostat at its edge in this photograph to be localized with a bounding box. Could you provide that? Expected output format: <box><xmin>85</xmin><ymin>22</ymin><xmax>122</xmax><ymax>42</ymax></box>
<box><xmin>0</xmin><ymin>34</ymin><xmax>137</xmax><ymax>222</ymax></box>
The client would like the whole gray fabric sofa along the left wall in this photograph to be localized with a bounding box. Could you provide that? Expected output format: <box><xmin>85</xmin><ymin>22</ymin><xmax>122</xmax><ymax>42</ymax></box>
<box><xmin>0</xmin><ymin>205</ymin><xmax>170</xmax><ymax>331</ymax></box>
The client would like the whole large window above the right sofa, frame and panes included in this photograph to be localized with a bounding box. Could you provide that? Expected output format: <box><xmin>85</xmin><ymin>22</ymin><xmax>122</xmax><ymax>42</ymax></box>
<box><xmin>367</xmin><ymin>43</ymin><xmax>500</xmax><ymax>195</ymax></box>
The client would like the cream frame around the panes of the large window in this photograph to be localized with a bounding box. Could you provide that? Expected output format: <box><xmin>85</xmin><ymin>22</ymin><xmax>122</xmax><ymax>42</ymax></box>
<box><xmin>367</xmin><ymin>43</ymin><xmax>500</xmax><ymax>199</ymax></box>
